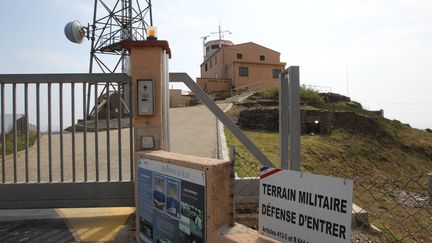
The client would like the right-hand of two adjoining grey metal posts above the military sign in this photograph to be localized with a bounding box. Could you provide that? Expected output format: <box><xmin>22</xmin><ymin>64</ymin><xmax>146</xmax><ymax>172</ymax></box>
<box><xmin>288</xmin><ymin>66</ymin><xmax>300</xmax><ymax>171</ymax></box>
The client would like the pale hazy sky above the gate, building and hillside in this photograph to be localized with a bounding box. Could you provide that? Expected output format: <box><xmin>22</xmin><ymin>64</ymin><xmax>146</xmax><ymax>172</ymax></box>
<box><xmin>0</xmin><ymin>0</ymin><xmax>432</xmax><ymax>129</ymax></box>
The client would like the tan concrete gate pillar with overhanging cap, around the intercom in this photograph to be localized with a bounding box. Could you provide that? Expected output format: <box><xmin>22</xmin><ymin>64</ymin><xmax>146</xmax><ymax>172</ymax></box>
<box><xmin>122</xmin><ymin>40</ymin><xmax>171</xmax><ymax>151</ymax></box>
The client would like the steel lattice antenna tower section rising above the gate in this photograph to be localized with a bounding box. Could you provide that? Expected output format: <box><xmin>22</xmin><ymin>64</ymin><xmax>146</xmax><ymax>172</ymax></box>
<box><xmin>88</xmin><ymin>0</ymin><xmax>153</xmax><ymax>73</ymax></box>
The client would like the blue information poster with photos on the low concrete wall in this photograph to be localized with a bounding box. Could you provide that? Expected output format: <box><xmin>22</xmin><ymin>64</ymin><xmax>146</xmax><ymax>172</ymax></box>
<box><xmin>138</xmin><ymin>157</ymin><xmax>206</xmax><ymax>243</ymax></box>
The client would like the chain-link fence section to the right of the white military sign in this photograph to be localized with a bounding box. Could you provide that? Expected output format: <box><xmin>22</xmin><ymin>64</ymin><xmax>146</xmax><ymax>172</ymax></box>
<box><xmin>353</xmin><ymin>173</ymin><xmax>432</xmax><ymax>242</ymax></box>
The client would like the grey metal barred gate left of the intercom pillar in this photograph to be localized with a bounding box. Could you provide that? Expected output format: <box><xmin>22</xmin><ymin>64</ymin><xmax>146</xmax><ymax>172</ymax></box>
<box><xmin>0</xmin><ymin>73</ymin><xmax>134</xmax><ymax>209</ymax></box>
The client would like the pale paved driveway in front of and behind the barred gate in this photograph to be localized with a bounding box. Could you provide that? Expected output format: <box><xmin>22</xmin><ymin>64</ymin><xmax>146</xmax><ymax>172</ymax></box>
<box><xmin>0</xmin><ymin>103</ymin><xmax>228</xmax><ymax>242</ymax></box>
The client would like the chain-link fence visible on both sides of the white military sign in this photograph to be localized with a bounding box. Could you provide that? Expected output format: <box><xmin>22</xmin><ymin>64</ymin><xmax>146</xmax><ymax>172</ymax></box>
<box><xmin>232</xmin><ymin>148</ymin><xmax>432</xmax><ymax>242</ymax></box>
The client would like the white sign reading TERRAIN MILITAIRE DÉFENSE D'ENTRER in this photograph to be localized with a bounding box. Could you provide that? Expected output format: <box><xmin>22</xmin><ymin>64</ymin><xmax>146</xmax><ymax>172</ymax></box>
<box><xmin>259</xmin><ymin>167</ymin><xmax>353</xmax><ymax>243</ymax></box>
